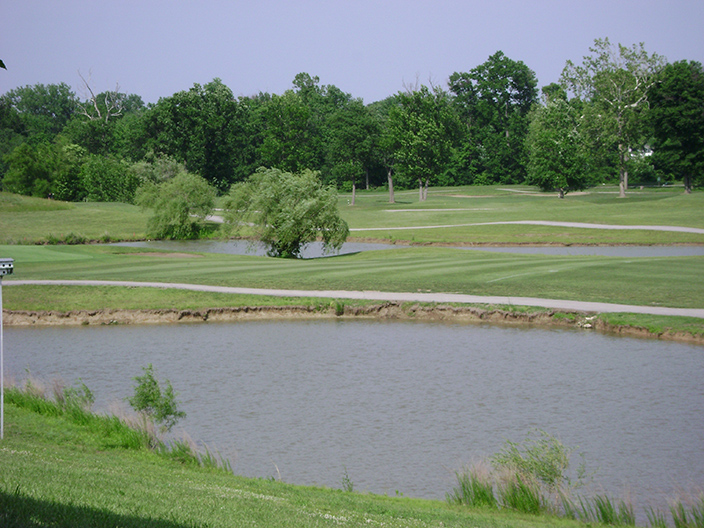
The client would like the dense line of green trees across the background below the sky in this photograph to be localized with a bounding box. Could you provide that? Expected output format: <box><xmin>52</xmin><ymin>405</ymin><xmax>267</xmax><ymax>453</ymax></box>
<box><xmin>0</xmin><ymin>39</ymin><xmax>704</xmax><ymax>202</ymax></box>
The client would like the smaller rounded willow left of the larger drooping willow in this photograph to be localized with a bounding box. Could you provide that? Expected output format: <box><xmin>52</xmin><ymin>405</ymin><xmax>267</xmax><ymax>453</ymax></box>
<box><xmin>136</xmin><ymin>170</ymin><xmax>216</xmax><ymax>239</ymax></box>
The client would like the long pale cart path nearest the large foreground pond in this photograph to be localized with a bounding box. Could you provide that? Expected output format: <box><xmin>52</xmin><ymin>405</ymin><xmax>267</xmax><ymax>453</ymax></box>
<box><xmin>4</xmin><ymin>280</ymin><xmax>704</xmax><ymax>318</ymax></box>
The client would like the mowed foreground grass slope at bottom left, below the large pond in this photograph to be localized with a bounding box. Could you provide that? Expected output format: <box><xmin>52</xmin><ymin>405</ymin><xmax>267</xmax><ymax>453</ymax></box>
<box><xmin>0</xmin><ymin>404</ymin><xmax>584</xmax><ymax>528</ymax></box>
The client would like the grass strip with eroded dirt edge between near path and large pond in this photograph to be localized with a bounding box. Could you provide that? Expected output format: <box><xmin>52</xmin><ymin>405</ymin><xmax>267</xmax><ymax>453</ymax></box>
<box><xmin>3</xmin><ymin>285</ymin><xmax>704</xmax><ymax>343</ymax></box>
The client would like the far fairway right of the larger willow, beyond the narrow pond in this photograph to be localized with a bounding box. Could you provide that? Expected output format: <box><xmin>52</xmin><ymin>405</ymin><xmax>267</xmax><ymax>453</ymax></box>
<box><xmin>340</xmin><ymin>186</ymin><xmax>704</xmax><ymax>245</ymax></box>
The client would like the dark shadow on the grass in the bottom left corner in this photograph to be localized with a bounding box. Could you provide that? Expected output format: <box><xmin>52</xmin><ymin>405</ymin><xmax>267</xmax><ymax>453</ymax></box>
<box><xmin>0</xmin><ymin>491</ymin><xmax>198</xmax><ymax>528</ymax></box>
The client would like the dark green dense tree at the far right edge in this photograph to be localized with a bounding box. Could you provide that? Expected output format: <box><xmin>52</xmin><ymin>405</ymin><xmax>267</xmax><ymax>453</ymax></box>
<box><xmin>649</xmin><ymin>61</ymin><xmax>704</xmax><ymax>193</ymax></box>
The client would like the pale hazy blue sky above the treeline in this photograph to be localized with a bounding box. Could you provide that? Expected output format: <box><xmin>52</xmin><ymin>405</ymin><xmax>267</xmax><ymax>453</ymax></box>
<box><xmin>0</xmin><ymin>0</ymin><xmax>704</xmax><ymax>103</ymax></box>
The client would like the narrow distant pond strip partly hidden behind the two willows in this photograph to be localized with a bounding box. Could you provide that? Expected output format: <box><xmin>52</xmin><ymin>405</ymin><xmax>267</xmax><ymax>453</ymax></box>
<box><xmin>114</xmin><ymin>240</ymin><xmax>704</xmax><ymax>258</ymax></box>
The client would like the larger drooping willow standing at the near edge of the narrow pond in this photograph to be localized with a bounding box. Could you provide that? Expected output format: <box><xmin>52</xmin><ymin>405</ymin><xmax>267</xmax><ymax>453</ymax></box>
<box><xmin>224</xmin><ymin>169</ymin><xmax>349</xmax><ymax>258</ymax></box>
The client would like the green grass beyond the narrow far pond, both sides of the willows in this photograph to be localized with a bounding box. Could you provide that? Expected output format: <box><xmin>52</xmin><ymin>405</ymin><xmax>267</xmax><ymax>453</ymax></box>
<box><xmin>0</xmin><ymin>185</ymin><xmax>704</xmax><ymax>245</ymax></box>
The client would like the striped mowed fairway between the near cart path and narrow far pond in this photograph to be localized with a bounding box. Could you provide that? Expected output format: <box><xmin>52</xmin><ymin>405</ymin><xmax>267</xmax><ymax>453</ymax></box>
<box><xmin>0</xmin><ymin>242</ymin><xmax>704</xmax><ymax>309</ymax></box>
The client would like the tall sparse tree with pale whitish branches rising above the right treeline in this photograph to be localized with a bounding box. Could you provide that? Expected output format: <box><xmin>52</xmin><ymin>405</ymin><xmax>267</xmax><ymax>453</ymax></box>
<box><xmin>561</xmin><ymin>39</ymin><xmax>665</xmax><ymax>197</ymax></box>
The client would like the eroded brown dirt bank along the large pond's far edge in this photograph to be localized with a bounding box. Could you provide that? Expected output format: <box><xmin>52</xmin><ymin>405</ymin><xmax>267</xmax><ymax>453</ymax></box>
<box><xmin>3</xmin><ymin>302</ymin><xmax>704</xmax><ymax>345</ymax></box>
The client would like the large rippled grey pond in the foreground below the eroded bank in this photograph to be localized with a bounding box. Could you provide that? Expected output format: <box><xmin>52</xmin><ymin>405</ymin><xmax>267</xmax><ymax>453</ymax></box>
<box><xmin>5</xmin><ymin>320</ymin><xmax>704</xmax><ymax>520</ymax></box>
